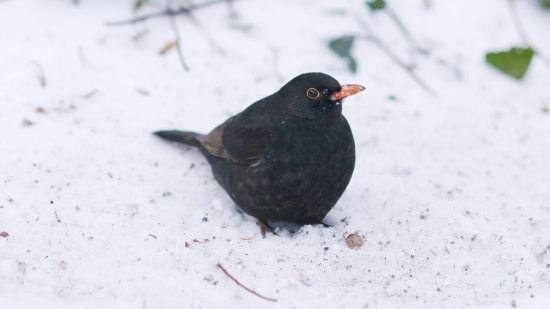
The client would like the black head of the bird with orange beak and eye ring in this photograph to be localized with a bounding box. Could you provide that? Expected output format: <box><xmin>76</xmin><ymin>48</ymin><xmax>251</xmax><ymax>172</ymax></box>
<box><xmin>279</xmin><ymin>73</ymin><xmax>365</xmax><ymax>125</ymax></box>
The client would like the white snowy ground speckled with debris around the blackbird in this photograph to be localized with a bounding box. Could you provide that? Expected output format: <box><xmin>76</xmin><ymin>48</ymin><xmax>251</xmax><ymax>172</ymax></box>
<box><xmin>0</xmin><ymin>0</ymin><xmax>550</xmax><ymax>308</ymax></box>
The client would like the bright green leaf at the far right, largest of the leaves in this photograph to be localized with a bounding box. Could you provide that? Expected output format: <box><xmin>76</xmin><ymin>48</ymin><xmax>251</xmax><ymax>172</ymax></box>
<box><xmin>485</xmin><ymin>47</ymin><xmax>535</xmax><ymax>80</ymax></box>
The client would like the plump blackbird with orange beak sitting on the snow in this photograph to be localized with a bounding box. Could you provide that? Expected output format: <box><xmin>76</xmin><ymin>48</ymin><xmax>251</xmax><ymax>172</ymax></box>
<box><xmin>153</xmin><ymin>73</ymin><xmax>365</xmax><ymax>238</ymax></box>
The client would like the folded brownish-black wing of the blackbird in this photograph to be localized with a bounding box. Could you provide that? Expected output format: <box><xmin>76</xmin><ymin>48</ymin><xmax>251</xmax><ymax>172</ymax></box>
<box><xmin>202</xmin><ymin>113</ymin><xmax>272</xmax><ymax>166</ymax></box>
